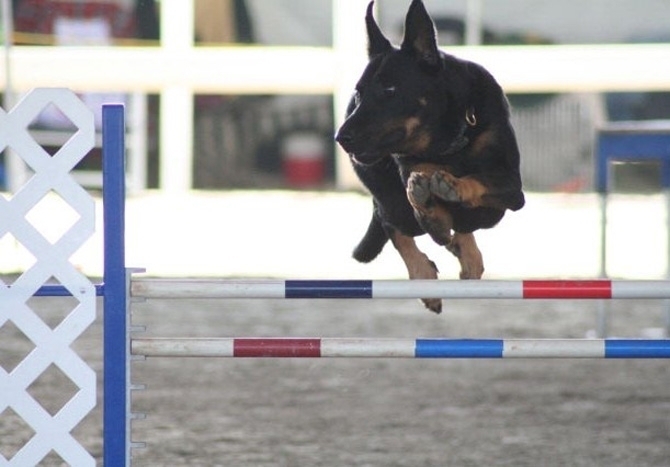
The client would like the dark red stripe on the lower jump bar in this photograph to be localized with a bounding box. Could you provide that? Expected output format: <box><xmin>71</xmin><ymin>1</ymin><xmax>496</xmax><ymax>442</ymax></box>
<box><xmin>233</xmin><ymin>338</ymin><xmax>321</xmax><ymax>358</ymax></box>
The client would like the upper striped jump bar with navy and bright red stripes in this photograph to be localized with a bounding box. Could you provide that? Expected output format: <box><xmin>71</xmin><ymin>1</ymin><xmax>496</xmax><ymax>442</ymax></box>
<box><xmin>130</xmin><ymin>278</ymin><xmax>670</xmax><ymax>299</ymax></box>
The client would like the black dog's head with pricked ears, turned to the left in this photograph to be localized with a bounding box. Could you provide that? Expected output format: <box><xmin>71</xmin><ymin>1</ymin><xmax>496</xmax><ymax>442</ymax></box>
<box><xmin>335</xmin><ymin>0</ymin><xmax>472</xmax><ymax>164</ymax></box>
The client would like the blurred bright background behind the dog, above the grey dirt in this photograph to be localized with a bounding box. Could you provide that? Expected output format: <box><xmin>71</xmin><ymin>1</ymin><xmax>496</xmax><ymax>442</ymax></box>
<box><xmin>0</xmin><ymin>0</ymin><xmax>670</xmax><ymax>277</ymax></box>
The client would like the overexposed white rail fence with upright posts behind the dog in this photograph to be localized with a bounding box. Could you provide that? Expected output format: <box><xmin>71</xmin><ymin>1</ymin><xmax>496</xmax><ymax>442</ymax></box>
<box><xmin>0</xmin><ymin>0</ymin><xmax>670</xmax><ymax>191</ymax></box>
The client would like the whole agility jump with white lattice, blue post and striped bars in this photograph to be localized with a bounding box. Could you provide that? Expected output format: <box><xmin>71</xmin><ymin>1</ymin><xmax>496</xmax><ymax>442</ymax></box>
<box><xmin>0</xmin><ymin>89</ymin><xmax>670</xmax><ymax>465</ymax></box>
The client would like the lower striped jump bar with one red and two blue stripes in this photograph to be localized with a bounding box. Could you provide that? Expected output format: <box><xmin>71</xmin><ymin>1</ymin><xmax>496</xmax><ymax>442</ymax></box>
<box><xmin>131</xmin><ymin>338</ymin><xmax>670</xmax><ymax>359</ymax></box>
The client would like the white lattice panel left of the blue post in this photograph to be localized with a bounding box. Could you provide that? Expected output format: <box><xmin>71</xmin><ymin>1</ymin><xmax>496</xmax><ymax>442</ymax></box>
<box><xmin>0</xmin><ymin>89</ymin><xmax>96</xmax><ymax>466</ymax></box>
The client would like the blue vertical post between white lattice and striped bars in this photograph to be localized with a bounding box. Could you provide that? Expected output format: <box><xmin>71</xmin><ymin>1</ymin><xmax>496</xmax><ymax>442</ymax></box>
<box><xmin>102</xmin><ymin>104</ymin><xmax>130</xmax><ymax>467</ymax></box>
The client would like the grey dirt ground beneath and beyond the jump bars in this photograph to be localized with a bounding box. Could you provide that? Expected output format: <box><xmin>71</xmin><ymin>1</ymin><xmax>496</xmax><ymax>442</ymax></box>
<box><xmin>0</xmin><ymin>299</ymin><xmax>670</xmax><ymax>467</ymax></box>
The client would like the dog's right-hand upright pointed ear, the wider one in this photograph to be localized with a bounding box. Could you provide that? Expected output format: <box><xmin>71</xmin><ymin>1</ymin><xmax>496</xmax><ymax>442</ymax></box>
<box><xmin>400</xmin><ymin>0</ymin><xmax>440</xmax><ymax>67</ymax></box>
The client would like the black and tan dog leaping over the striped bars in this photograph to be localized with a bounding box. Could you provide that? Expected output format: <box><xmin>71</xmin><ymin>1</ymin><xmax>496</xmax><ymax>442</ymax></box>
<box><xmin>335</xmin><ymin>0</ymin><xmax>525</xmax><ymax>313</ymax></box>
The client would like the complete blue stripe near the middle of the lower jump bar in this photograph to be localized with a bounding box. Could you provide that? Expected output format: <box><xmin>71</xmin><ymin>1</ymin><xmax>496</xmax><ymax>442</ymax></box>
<box><xmin>414</xmin><ymin>339</ymin><xmax>503</xmax><ymax>358</ymax></box>
